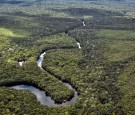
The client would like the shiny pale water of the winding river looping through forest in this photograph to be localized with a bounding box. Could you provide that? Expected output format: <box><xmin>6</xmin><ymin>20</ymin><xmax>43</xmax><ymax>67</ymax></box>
<box><xmin>10</xmin><ymin>42</ymin><xmax>81</xmax><ymax>106</ymax></box>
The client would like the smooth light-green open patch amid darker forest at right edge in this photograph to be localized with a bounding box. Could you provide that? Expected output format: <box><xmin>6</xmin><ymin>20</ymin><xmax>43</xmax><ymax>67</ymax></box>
<box><xmin>97</xmin><ymin>30</ymin><xmax>135</xmax><ymax>61</ymax></box>
